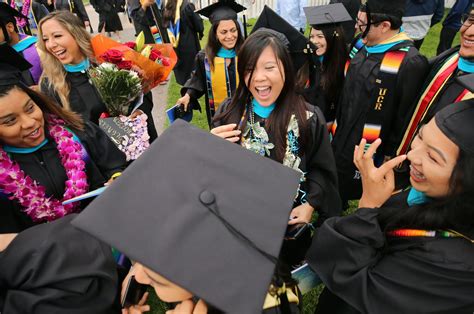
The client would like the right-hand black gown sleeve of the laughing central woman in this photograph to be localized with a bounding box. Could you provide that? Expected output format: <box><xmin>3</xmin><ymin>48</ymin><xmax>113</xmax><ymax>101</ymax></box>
<box><xmin>306</xmin><ymin>107</ymin><xmax>342</xmax><ymax>225</ymax></box>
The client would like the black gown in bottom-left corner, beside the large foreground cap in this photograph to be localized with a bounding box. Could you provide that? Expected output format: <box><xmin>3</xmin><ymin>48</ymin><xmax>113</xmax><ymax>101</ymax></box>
<box><xmin>0</xmin><ymin>215</ymin><xmax>120</xmax><ymax>314</ymax></box>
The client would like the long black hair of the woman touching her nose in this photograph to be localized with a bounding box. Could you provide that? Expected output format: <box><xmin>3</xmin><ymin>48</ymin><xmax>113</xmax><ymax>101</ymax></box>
<box><xmin>378</xmin><ymin>150</ymin><xmax>474</xmax><ymax>236</ymax></box>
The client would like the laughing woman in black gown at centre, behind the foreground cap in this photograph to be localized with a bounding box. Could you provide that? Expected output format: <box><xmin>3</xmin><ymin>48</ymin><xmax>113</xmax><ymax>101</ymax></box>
<box><xmin>211</xmin><ymin>29</ymin><xmax>341</xmax><ymax>285</ymax></box>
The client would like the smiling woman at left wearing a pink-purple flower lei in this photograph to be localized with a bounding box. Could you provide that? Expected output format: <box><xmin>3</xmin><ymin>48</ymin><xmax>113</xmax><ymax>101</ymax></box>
<box><xmin>0</xmin><ymin>66</ymin><xmax>125</xmax><ymax>233</ymax></box>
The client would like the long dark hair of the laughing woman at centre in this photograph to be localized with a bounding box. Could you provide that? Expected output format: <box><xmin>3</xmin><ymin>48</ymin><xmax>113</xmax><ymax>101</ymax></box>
<box><xmin>214</xmin><ymin>30</ymin><xmax>308</xmax><ymax>162</ymax></box>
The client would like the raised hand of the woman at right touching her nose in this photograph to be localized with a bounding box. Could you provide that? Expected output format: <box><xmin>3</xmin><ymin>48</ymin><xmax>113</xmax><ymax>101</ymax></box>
<box><xmin>354</xmin><ymin>139</ymin><xmax>407</xmax><ymax>208</ymax></box>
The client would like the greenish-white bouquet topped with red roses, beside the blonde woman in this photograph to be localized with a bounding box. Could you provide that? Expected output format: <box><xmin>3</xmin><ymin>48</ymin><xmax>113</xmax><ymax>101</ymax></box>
<box><xmin>89</xmin><ymin>59</ymin><xmax>142</xmax><ymax>117</ymax></box>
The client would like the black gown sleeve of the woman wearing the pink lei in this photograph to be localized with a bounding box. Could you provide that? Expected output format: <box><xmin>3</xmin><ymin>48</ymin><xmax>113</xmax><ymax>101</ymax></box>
<box><xmin>81</xmin><ymin>122</ymin><xmax>126</xmax><ymax>179</ymax></box>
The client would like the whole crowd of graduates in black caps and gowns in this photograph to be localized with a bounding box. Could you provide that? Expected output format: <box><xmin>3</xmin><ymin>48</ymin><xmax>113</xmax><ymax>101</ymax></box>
<box><xmin>0</xmin><ymin>0</ymin><xmax>474</xmax><ymax>314</ymax></box>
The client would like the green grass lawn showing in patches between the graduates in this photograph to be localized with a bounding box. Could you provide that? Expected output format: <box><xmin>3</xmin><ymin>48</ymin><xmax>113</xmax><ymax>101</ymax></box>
<box><xmin>149</xmin><ymin>13</ymin><xmax>459</xmax><ymax>313</ymax></box>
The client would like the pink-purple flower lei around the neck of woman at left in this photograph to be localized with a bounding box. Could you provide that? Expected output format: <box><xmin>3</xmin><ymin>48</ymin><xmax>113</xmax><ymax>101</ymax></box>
<box><xmin>0</xmin><ymin>116</ymin><xmax>88</xmax><ymax>222</ymax></box>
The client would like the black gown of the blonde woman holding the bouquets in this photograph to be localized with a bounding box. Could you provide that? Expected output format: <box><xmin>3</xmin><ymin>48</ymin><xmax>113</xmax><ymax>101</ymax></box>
<box><xmin>41</xmin><ymin>72</ymin><xmax>158</xmax><ymax>141</ymax></box>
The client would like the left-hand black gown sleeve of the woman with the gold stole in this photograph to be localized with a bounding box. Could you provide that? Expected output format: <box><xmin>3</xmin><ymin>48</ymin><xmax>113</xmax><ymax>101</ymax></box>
<box><xmin>181</xmin><ymin>51</ymin><xmax>206</xmax><ymax>111</ymax></box>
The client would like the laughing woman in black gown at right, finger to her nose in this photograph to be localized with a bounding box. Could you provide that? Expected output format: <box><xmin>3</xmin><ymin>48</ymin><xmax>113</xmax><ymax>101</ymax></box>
<box><xmin>307</xmin><ymin>100</ymin><xmax>474</xmax><ymax>314</ymax></box>
